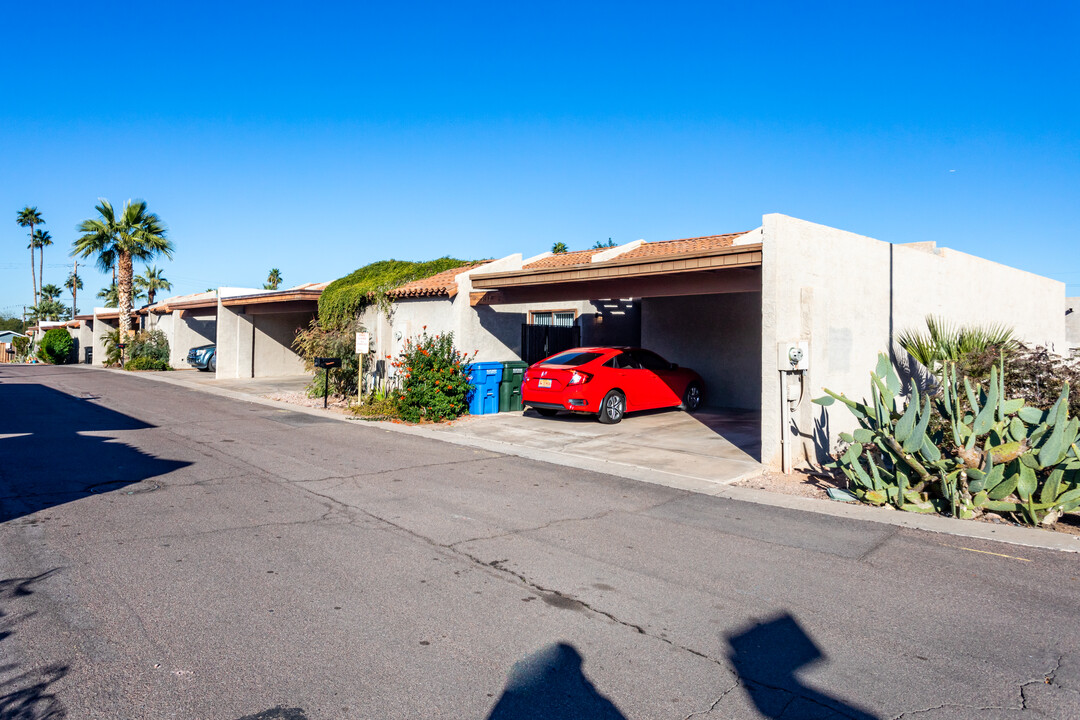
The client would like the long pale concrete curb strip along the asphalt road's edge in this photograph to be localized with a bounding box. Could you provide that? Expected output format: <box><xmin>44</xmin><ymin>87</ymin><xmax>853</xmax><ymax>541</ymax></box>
<box><xmin>103</xmin><ymin>368</ymin><xmax>1080</xmax><ymax>553</ymax></box>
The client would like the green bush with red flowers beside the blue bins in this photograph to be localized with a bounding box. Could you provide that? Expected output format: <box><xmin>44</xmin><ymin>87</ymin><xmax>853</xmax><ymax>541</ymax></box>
<box><xmin>392</xmin><ymin>326</ymin><xmax>475</xmax><ymax>422</ymax></box>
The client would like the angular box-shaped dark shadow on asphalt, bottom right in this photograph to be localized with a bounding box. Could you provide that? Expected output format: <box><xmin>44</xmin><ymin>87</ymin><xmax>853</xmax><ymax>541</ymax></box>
<box><xmin>728</xmin><ymin>614</ymin><xmax>879</xmax><ymax>720</ymax></box>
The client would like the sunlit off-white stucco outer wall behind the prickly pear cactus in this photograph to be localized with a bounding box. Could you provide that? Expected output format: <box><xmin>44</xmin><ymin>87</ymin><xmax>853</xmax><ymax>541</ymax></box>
<box><xmin>761</xmin><ymin>215</ymin><xmax>1065</xmax><ymax>467</ymax></box>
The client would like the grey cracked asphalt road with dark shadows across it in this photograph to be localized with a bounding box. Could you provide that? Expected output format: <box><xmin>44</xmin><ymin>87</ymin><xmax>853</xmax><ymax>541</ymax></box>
<box><xmin>0</xmin><ymin>366</ymin><xmax>1080</xmax><ymax>720</ymax></box>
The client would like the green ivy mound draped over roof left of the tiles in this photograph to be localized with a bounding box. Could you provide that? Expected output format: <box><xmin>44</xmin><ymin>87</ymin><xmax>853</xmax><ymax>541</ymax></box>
<box><xmin>319</xmin><ymin>257</ymin><xmax>469</xmax><ymax>327</ymax></box>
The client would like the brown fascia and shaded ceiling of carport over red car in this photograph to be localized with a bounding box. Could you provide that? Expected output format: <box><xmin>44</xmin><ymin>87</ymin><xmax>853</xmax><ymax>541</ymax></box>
<box><xmin>470</xmin><ymin>243</ymin><xmax>761</xmax><ymax>305</ymax></box>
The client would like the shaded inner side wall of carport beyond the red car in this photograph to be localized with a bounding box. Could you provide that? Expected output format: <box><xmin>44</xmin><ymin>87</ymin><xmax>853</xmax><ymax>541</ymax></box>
<box><xmin>642</xmin><ymin>293</ymin><xmax>761</xmax><ymax>409</ymax></box>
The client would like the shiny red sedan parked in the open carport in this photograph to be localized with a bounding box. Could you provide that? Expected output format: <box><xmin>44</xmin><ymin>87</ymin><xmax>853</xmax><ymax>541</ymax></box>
<box><xmin>522</xmin><ymin>348</ymin><xmax>705</xmax><ymax>423</ymax></box>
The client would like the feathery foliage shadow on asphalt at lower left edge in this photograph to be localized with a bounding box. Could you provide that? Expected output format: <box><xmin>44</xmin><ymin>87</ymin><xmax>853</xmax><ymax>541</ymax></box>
<box><xmin>0</xmin><ymin>569</ymin><xmax>68</xmax><ymax>720</ymax></box>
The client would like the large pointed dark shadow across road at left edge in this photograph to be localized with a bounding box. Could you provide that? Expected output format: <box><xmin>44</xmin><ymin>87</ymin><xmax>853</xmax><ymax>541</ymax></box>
<box><xmin>0</xmin><ymin>379</ymin><xmax>190</xmax><ymax>521</ymax></box>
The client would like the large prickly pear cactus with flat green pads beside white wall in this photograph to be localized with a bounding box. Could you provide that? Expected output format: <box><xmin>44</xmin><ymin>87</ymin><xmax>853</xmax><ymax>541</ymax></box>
<box><xmin>813</xmin><ymin>355</ymin><xmax>1080</xmax><ymax>526</ymax></box>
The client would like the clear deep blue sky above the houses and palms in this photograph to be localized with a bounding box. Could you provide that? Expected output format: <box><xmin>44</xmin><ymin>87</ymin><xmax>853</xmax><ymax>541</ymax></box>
<box><xmin>0</xmin><ymin>0</ymin><xmax>1080</xmax><ymax>313</ymax></box>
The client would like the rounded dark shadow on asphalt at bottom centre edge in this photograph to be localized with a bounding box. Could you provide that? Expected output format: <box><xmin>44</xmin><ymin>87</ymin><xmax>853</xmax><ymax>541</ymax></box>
<box><xmin>487</xmin><ymin>642</ymin><xmax>626</xmax><ymax>720</ymax></box>
